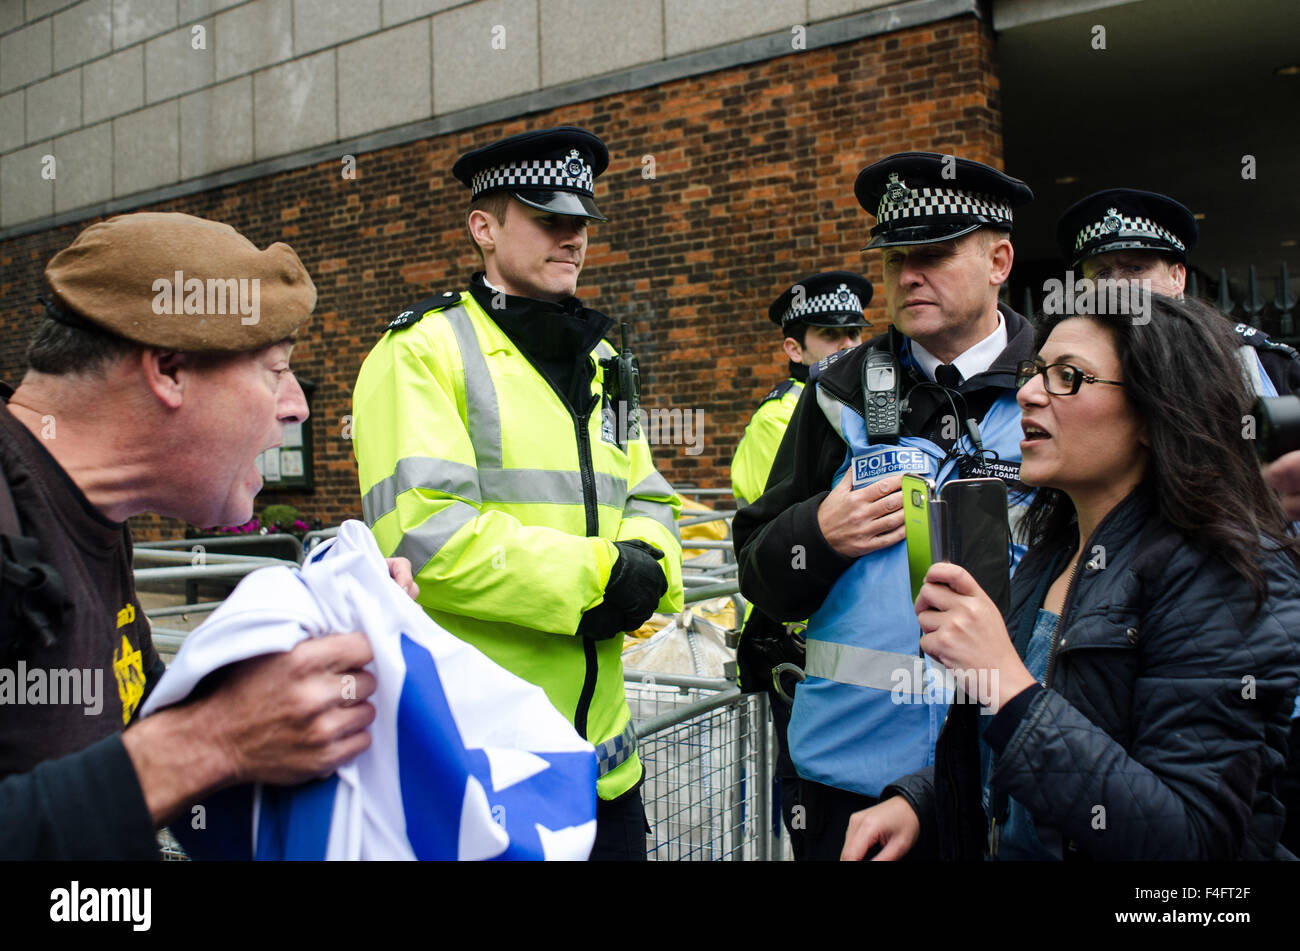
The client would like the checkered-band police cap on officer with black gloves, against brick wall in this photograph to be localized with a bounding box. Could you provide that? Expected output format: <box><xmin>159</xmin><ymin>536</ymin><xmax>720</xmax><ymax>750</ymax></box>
<box><xmin>451</xmin><ymin>126</ymin><xmax>610</xmax><ymax>221</ymax></box>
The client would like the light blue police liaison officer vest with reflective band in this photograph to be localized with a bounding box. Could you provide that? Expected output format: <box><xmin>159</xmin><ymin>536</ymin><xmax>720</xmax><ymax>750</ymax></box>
<box><xmin>789</xmin><ymin>381</ymin><xmax>1024</xmax><ymax>796</ymax></box>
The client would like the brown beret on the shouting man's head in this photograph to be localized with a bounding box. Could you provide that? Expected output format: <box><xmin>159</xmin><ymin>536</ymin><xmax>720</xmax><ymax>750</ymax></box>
<box><xmin>46</xmin><ymin>212</ymin><xmax>316</xmax><ymax>351</ymax></box>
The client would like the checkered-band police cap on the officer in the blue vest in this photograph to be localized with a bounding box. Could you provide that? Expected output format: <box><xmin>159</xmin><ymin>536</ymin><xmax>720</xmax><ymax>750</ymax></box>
<box><xmin>853</xmin><ymin>152</ymin><xmax>1034</xmax><ymax>251</ymax></box>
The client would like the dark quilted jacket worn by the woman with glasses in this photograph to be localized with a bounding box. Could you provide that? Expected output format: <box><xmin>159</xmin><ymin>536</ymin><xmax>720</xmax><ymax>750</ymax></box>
<box><xmin>881</xmin><ymin>487</ymin><xmax>1300</xmax><ymax>860</ymax></box>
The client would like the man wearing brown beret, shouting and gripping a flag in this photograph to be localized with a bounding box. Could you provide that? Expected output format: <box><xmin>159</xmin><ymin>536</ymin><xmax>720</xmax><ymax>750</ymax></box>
<box><xmin>0</xmin><ymin>214</ymin><xmax>410</xmax><ymax>859</ymax></box>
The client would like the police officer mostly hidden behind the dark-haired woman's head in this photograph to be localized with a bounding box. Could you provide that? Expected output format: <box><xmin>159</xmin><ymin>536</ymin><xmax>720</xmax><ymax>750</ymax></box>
<box><xmin>1057</xmin><ymin>188</ymin><xmax>1300</xmax><ymax>396</ymax></box>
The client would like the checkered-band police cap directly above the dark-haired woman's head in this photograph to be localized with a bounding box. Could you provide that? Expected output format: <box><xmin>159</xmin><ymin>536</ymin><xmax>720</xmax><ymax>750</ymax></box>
<box><xmin>1057</xmin><ymin>188</ymin><xmax>1197</xmax><ymax>268</ymax></box>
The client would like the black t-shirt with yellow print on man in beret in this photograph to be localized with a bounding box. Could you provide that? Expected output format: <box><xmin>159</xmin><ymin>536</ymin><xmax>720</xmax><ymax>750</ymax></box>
<box><xmin>0</xmin><ymin>394</ymin><xmax>157</xmax><ymax>777</ymax></box>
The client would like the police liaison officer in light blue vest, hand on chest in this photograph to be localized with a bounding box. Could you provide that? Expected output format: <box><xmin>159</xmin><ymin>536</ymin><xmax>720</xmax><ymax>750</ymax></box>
<box><xmin>733</xmin><ymin>152</ymin><xmax>1034</xmax><ymax>859</ymax></box>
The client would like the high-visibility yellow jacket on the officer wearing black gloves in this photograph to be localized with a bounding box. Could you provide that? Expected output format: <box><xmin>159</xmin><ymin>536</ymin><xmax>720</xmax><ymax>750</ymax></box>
<box><xmin>352</xmin><ymin>292</ymin><xmax>683</xmax><ymax>799</ymax></box>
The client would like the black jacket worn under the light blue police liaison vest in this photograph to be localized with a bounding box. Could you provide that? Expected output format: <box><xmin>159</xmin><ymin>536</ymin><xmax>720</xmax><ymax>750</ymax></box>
<box><xmin>732</xmin><ymin>304</ymin><xmax>1034</xmax><ymax>621</ymax></box>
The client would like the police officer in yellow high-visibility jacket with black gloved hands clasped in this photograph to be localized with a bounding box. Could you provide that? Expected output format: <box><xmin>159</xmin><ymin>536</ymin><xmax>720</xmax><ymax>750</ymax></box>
<box><xmin>352</xmin><ymin>126</ymin><xmax>683</xmax><ymax>860</ymax></box>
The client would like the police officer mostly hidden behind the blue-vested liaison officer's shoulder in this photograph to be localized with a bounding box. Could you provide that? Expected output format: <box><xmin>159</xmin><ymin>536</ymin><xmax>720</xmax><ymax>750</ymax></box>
<box><xmin>731</xmin><ymin>270</ymin><xmax>871</xmax><ymax>859</ymax></box>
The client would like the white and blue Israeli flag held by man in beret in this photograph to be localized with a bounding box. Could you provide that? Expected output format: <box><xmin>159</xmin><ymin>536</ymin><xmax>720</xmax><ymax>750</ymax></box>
<box><xmin>143</xmin><ymin>521</ymin><xmax>597</xmax><ymax>860</ymax></box>
